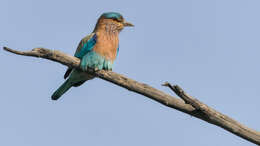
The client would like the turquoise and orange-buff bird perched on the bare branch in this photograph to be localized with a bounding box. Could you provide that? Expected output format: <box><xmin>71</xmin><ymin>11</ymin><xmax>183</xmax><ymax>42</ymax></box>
<box><xmin>51</xmin><ymin>12</ymin><xmax>134</xmax><ymax>100</ymax></box>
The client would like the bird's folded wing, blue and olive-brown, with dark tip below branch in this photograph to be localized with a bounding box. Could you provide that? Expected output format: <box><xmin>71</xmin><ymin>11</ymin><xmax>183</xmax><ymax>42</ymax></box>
<box><xmin>64</xmin><ymin>33</ymin><xmax>97</xmax><ymax>79</ymax></box>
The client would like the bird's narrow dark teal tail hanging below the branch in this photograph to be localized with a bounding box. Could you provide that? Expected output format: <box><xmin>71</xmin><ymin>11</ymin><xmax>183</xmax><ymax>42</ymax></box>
<box><xmin>51</xmin><ymin>79</ymin><xmax>73</xmax><ymax>100</ymax></box>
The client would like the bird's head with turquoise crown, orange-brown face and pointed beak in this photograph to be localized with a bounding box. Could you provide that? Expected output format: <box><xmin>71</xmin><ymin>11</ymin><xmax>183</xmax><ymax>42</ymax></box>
<box><xmin>95</xmin><ymin>12</ymin><xmax>134</xmax><ymax>31</ymax></box>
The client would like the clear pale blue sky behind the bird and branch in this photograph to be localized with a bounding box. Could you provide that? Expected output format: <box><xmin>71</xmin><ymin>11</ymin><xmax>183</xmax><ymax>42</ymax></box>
<box><xmin>0</xmin><ymin>0</ymin><xmax>260</xmax><ymax>146</ymax></box>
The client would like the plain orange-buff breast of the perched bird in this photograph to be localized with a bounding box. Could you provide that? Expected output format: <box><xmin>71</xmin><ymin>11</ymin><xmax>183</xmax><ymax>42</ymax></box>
<box><xmin>93</xmin><ymin>33</ymin><xmax>119</xmax><ymax>62</ymax></box>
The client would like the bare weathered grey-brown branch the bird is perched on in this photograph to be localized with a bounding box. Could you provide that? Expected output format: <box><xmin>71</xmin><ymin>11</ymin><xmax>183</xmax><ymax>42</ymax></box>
<box><xmin>3</xmin><ymin>47</ymin><xmax>260</xmax><ymax>145</ymax></box>
